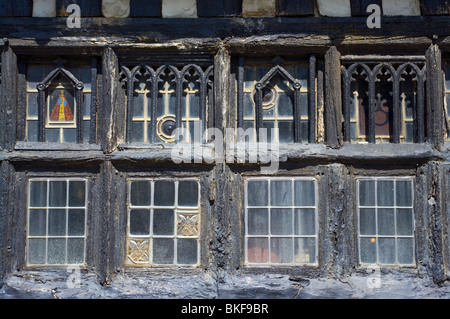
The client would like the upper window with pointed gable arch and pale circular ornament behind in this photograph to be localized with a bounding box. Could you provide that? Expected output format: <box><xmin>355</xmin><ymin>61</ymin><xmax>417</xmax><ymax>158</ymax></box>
<box><xmin>236</xmin><ymin>55</ymin><xmax>320</xmax><ymax>143</ymax></box>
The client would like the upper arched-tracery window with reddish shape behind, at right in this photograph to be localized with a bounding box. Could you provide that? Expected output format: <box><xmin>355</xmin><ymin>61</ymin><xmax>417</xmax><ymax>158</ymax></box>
<box><xmin>342</xmin><ymin>56</ymin><xmax>425</xmax><ymax>143</ymax></box>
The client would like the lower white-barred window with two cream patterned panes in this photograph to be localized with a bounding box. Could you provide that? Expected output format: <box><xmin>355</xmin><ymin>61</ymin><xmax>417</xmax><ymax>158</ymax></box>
<box><xmin>127</xmin><ymin>179</ymin><xmax>200</xmax><ymax>266</ymax></box>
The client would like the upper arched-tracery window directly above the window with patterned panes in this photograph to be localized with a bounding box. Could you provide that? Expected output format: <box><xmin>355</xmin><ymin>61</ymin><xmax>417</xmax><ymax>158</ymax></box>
<box><xmin>121</xmin><ymin>64</ymin><xmax>214</xmax><ymax>144</ymax></box>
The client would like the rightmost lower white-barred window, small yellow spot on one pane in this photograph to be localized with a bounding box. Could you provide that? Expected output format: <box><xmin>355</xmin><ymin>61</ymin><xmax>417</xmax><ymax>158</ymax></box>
<box><xmin>358</xmin><ymin>178</ymin><xmax>414</xmax><ymax>266</ymax></box>
